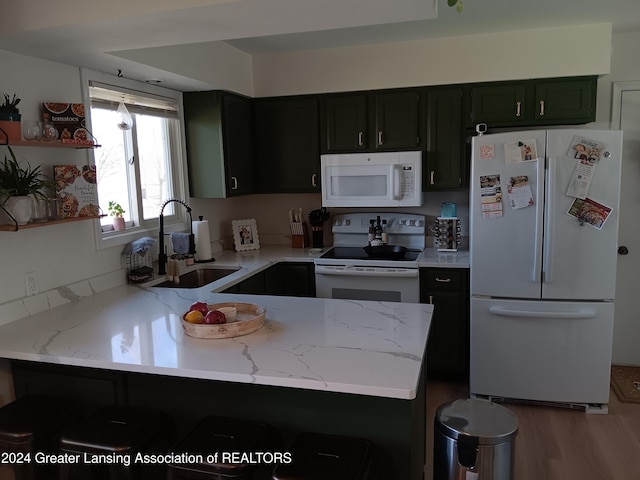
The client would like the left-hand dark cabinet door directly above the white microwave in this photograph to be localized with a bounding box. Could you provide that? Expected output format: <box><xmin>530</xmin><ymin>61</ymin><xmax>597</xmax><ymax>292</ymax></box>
<box><xmin>321</xmin><ymin>94</ymin><xmax>368</xmax><ymax>152</ymax></box>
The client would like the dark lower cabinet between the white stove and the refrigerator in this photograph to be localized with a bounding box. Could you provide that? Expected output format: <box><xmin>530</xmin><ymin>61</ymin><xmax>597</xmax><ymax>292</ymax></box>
<box><xmin>420</xmin><ymin>268</ymin><xmax>469</xmax><ymax>381</ymax></box>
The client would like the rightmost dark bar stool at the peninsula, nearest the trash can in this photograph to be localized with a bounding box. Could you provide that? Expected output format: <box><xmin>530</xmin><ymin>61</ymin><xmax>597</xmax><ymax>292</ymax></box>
<box><xmin>272</xmin><ymin>432</ymin><xmax>374</xmax><ymax>480</ymax></box>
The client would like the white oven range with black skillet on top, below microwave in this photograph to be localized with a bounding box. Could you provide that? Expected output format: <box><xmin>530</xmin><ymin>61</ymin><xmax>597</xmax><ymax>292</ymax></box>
<box><xmin>315</xmin><ymin>212</ymin><xmax>426</xmax><ymax>303</ymax></box>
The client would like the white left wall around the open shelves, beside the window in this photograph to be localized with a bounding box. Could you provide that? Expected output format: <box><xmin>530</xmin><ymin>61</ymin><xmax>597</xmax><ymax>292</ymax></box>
<box><xmin>0</xmin><ymin>50</ymin><xmax>120</xmax><ymax>306</ymax></box>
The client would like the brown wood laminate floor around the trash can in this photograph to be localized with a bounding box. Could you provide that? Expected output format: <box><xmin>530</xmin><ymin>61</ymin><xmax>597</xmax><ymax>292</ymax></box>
<box><xmin>426</xmin><ymin>381</ymin><xmax>640</xmax><ymax>480</ymax></box>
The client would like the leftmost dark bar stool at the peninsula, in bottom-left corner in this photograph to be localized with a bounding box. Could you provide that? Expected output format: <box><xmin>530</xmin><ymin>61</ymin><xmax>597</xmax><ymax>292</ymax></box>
<box><xmin>0</xmin><ymin>395</ymin><xmax>80</xmax><ymax>480</ymax></box>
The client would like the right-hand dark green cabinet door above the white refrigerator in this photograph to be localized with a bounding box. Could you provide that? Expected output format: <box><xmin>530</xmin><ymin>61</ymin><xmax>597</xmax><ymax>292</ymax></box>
<box><xmin>535</xmin><ymin>77</ymin><xmax>597</xmax><ymax>125</ymax></box>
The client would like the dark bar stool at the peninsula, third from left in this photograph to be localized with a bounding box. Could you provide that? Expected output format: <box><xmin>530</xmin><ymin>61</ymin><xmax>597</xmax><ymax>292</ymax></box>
<box><xmin>167</xmin><ymin>416</ymin><xmax>279</xmax><ymax>480</ymax></box>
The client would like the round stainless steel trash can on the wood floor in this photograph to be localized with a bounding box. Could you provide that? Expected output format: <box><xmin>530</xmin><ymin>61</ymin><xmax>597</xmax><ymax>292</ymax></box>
<box><xmin>433</xmin><ymin>398</ymin><xmax>518</xmax><ymax>480</ymax></box>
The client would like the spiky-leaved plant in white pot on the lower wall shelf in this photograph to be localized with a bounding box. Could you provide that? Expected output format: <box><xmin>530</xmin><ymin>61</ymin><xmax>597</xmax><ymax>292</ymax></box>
<box><xmin>0</xmin><ymin>145</ymin><xmax>54</xmax><ymax>225</ymax></box>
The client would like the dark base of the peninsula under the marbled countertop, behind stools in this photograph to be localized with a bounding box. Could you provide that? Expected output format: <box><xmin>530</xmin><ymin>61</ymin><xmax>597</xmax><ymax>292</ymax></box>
<box><xmin>12</xmin><ymin>362</ymin><xmax>426</xmax><ymax>480</ymax></box>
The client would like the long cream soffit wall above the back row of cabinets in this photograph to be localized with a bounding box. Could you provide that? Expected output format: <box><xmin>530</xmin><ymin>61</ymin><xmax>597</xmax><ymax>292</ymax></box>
<box><xmin>253</xmin><ymin>23</ymin><xmax>611</xmax><ymax>97</ymax></box>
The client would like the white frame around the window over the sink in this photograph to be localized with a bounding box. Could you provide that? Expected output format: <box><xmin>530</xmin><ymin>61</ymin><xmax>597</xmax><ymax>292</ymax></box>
<box><xmin>80</xmin><ymin>68</ymin><xmax>190</xmax><ymax>250</ymax></box>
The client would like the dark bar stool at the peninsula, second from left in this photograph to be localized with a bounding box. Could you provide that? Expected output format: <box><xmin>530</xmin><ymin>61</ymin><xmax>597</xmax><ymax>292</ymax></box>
<box><xmin>60</xmin><ymin>405</ymin><xmax>173</xmax><ymax>480</ymax></box>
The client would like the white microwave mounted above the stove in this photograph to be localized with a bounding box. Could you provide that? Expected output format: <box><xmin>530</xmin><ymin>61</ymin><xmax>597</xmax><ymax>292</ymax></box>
<box><xmin>320</xmin><ymin>152</ymin><xmax>423</xmax><ymax>207</ymax></box>
